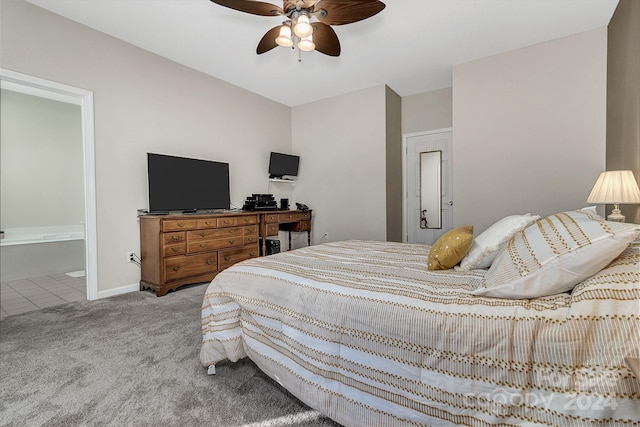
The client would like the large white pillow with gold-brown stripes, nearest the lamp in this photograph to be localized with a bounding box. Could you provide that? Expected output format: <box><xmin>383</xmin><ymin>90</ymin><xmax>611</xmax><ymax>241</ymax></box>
<box><xmin>474</xmin><ymin>211</ymin><xmax>640</xmax><ymax>298</ymax></box>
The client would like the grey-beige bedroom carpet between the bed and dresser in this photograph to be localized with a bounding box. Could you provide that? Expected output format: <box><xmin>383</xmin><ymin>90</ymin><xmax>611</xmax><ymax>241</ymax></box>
<box><xmin>0</xmin><ymin>285</ymin><xmax>337</xmax><ymax>427</ymax></box>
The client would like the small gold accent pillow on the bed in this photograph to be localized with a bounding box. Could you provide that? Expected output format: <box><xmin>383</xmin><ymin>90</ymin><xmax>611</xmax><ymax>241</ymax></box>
<box><xmin>427</xmin><ymin>225</ymin><xmax>473</xmax><ymax>270</ymax></box>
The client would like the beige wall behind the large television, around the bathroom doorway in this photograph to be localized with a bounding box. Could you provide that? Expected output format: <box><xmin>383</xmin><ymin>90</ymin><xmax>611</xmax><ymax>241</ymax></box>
<box><xmin>0</xmin><ymin>1</ymin><xmax>291</xmax><ymax>292</ymax></box>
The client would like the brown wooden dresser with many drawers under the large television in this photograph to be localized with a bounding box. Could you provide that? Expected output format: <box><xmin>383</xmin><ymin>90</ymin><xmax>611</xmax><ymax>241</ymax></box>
<box><xmin>140</xmin><ymin>212</ymin><xmax>260</xmax><ymax>297</ymax></box>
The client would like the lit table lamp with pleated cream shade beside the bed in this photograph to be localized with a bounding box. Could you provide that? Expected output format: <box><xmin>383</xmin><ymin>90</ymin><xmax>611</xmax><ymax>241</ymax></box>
<box><xmin>587</xmin><ymin>170</ymin><xmax>640</xmax><ymax>222</ymax></box>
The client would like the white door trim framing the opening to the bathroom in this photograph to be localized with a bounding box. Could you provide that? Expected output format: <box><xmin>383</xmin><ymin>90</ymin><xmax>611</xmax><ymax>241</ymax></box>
<box><xmin>0</xmin><ymin>68</ymin><xmax>99</xmax><ymax>300</ymax></box>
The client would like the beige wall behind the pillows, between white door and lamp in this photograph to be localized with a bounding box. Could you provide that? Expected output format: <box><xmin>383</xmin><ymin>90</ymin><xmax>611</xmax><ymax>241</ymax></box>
<box><xmin>453</xmin><ymin>28</ymin><xmax>607</xmax><ymax>234</ymax></box>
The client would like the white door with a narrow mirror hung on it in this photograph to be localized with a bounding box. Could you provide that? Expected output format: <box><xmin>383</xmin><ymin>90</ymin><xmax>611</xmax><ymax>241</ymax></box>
<box><xmin>403</xmin><ymin>129</ymin><xmax>453</xmax><ymax>245</ymax></box>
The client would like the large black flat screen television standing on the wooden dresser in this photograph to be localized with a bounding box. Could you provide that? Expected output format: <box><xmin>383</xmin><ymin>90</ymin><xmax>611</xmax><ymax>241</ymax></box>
<box><xmin>147</xmin><ymin>153</ymin><xmax>231</xmax><ymax>212</ymax></box>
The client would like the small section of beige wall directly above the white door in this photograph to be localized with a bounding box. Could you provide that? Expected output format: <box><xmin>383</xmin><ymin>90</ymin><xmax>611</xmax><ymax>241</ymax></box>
<box><xmin>402</xmin><ymin>87</ymin><xmax>453</xmax><ymax>133</ymax></box>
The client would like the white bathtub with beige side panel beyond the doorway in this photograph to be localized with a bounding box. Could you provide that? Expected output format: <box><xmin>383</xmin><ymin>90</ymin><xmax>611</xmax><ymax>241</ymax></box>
<box><xmin>0</xmin><ymin>225</ymin><xmax>85</xmax><ymax>282</ymax></box>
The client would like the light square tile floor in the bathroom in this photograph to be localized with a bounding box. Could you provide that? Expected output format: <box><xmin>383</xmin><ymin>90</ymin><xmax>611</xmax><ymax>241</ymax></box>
<box><xmin>0</xmin><ymin>273</ymin><xmax>87</xmax><ymax>319</ymax></box>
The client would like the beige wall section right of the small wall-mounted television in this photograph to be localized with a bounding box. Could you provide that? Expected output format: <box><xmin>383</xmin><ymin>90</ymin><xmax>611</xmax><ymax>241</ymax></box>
<box><xmin>291</xmin><ymin>86</ymin><xmax>387</xmax><ymax>241</ymax></box>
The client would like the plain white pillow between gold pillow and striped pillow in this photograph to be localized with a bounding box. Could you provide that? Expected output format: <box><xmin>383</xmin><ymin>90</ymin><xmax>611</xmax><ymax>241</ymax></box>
<box><xmin>459</xmin><ymin>214</ymin><xmax>540</xmax><ymax>270</ymax></box>
